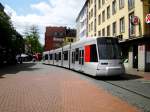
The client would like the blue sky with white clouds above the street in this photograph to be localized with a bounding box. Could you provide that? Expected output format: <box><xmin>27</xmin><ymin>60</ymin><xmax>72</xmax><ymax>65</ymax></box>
<box><xmin>0</xmin><ymin>0</ymin><xmax>85</xmax><ymax>45</ymax></box>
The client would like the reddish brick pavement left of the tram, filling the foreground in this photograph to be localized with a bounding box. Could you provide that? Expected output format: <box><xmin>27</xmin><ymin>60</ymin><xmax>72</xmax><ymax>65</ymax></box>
<box><xmin>0</xmin><ymin>63</ymin><xmax>140</xmax><ymax>112</ymax></box>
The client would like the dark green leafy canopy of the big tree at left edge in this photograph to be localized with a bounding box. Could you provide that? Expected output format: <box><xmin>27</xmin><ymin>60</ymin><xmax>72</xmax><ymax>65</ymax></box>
<box><xmin>0</xmin><ymin>11</ymin><xmax>24</xmax><ymax>53</ymax></box>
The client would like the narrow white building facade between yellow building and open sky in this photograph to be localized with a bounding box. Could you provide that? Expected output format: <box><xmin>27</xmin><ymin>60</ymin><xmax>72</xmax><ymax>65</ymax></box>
<box><xmin>76</xmin><ymin>1</ymin><xmax>88</xmax><ymax>40</ymax></box>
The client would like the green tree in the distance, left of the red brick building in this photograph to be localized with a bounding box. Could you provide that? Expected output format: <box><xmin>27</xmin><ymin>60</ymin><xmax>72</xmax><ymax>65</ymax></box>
<box><xmin>25</xmin><ymin>25</ymin><xmax>43</xmax><ymax>54</ymax></box>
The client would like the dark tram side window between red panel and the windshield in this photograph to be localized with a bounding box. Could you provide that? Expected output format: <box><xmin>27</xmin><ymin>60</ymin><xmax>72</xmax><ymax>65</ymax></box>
<box><xmin>90</xmin><ymin>44</ymin><xmax>98</xmax><ymax>62</ymax></box>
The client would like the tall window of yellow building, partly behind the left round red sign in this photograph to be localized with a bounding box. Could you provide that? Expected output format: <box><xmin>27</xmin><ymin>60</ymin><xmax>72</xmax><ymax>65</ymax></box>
<box><xmin>129</xmin><ymin>12</ymin><xmax>135</xmax><ymax>37</ymax></box>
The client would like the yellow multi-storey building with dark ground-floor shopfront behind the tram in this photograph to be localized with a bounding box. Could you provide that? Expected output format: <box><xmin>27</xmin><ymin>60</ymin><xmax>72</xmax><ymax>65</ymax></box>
<box><xmin>77</xmin><ymin>0</ymin><xmax>150</xmax><ymax>71</ymax></box>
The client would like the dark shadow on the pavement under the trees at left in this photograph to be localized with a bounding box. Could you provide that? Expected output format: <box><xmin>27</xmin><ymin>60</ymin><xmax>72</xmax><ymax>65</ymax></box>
<box><xmin>0</xmin><ymin>62</ymin><xmax>40</xmax><ymax>78</ymax></box>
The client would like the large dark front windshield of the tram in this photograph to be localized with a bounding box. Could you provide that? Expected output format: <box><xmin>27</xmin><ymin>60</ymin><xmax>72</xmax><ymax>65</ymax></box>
<box><xmin>97</xmin><ymin>37</ymin><xmax>121</xmax><ymax>59</ymax></box>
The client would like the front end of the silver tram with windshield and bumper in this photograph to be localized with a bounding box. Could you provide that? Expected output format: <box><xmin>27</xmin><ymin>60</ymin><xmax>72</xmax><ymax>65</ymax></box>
<box><xmin>97</xmin><ymin>37</ymin><xmax>125</xmax><ymax>76</ymax></box>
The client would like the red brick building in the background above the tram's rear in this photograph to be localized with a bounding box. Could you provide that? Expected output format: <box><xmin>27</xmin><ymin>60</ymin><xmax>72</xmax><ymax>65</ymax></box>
<box><xmin>45</xmin><ymin>27</ymin><xmax>76</xmax><ymax>51</ymax></box>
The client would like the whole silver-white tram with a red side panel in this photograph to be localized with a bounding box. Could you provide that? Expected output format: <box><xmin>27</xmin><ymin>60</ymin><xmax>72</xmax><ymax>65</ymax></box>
<box><xmin>43</xmin><ymin>37</ymin><xmax>125</xmax><ymax>76</ymax></box>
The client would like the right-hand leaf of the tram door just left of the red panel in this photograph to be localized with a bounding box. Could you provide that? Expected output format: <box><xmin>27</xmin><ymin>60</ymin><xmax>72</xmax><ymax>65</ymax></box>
<box><xmin>79</xmin><ymin>48</ymin><xmax>84</xmax><ymax>72</ymax></box>
